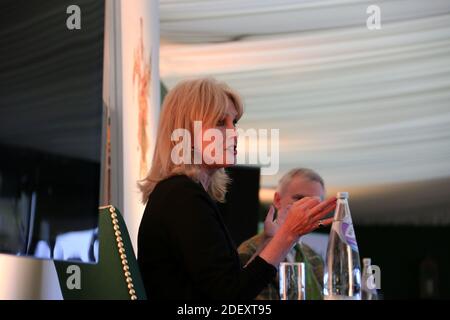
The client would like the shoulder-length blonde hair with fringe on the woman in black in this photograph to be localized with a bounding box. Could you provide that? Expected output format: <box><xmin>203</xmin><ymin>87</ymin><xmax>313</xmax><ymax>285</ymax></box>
<box><xmin>138</xmin><ymin>78</ymin><xmax>243</xmax><ymax>203</ymax></box>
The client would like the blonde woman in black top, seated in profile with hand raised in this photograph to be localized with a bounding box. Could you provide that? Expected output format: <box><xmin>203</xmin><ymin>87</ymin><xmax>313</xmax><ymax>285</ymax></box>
<box><xmin>138</xmin><ymin>79</ymin><xmax>336</xmax><ymax>299</ymax></box>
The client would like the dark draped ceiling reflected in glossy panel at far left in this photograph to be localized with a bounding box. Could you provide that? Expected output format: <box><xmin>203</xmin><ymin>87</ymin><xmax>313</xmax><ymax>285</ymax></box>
<box><xmin>0</xmin><ymin>0</ymin><xmax>104</xmax><ymax>163</ymax></box>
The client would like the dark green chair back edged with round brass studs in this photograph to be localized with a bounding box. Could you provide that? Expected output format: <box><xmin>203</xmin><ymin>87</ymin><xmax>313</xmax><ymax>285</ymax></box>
<box><xmin>55</xmin><ymin>206</ymin><xmax>147</xmax><ymax>300</ymax></box>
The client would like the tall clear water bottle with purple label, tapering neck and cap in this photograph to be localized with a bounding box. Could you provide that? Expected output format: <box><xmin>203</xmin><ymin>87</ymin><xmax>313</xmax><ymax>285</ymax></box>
<box><xmin>323</xmin><ymin>192</ymin><xmax>361</xmax><ymax>300</ymax></box>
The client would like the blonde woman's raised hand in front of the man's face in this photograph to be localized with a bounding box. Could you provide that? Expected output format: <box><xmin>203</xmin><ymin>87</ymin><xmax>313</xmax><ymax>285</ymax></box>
<box><xmin>279</xmin><ymin>197</ymin><xmax>336</xmax><ymax>241</ymax></box>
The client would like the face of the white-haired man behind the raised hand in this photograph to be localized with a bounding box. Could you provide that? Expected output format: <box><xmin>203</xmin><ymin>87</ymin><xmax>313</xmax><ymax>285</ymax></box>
<box><xmin>274</xmin><ymin>176</ymin><xmax>325</xmax><ymax>212</ymax></box>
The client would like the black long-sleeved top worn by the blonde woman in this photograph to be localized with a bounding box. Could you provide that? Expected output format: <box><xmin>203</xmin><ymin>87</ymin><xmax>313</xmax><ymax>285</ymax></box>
<box><xmin>138</xmin><ymin>175</ymin><xmax>276</xmax><ymax>299</ymax></box>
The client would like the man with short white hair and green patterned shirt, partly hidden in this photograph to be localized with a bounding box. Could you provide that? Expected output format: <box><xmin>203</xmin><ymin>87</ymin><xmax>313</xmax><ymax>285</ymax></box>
<box><xmin>238</xmin><ymin>168</ymin><xmax>325</xmax><ymax>300</ymax></box>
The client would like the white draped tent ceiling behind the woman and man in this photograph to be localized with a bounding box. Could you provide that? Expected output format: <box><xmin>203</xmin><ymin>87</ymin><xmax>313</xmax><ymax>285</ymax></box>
<box><xmin>160</xmin><ymin>0</ymin><xmax>450</xmax><ymax>222</ymax></box>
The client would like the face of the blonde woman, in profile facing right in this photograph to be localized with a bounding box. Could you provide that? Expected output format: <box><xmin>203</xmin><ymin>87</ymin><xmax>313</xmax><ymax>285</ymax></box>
<box><xmin>198</xmin><ymin>99</ymin><xmax>238</xmax><ymax>168</ymax></box>
